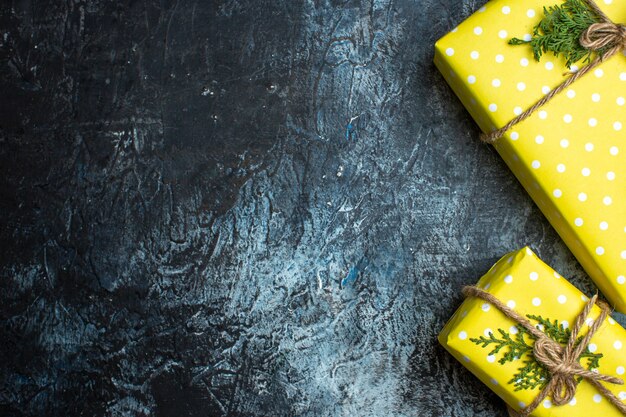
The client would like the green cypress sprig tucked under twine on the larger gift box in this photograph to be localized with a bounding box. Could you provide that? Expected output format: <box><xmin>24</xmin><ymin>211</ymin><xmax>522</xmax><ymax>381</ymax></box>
<box><xmin>509</xmin><ymin>0</ymin><xmax>608</xmax><ymax>68</ymax></box>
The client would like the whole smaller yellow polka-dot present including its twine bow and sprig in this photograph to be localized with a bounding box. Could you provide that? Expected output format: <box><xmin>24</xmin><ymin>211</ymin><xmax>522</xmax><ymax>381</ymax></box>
<box><xmin>439</xmin><ymin>248</ymin><xmax>626</xmax><ymax>417</ymax></box>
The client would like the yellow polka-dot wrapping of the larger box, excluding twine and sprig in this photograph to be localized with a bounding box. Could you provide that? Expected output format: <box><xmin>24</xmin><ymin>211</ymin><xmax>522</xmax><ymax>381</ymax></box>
<box><xmin>435</xmin><ymin>0</ymin><xmax>626</xmax><ymax>312</ymax></box>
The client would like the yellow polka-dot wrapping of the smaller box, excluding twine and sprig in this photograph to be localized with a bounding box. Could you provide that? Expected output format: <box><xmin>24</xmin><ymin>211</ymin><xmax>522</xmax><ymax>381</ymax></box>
<box><xmin>439</xmin><ymin>248</ymin><xmax>626</xmax><ymax>417</ymax></box>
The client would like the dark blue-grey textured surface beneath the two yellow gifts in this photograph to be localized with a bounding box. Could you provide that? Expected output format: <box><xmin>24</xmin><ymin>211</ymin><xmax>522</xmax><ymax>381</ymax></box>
<box><xmin>0</xmin><ymin>0</ymin><xmax>620</xmax><ymax>416</ymax></box>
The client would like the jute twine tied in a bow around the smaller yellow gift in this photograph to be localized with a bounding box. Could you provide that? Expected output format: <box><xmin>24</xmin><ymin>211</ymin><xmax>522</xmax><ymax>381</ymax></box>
<box><xmin>463</xmin><ymin>286</ymin><xmax>626</xmax><ymax>417</ymax></box>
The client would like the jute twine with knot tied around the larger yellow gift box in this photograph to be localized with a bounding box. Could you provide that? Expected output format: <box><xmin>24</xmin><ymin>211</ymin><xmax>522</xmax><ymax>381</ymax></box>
<box><xmin>480</xmin><ymin>0</ymin><xmax>626</xmax><ymax>144</ymax></box>
